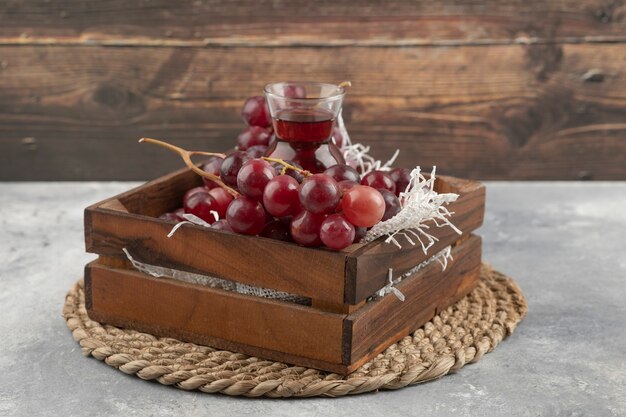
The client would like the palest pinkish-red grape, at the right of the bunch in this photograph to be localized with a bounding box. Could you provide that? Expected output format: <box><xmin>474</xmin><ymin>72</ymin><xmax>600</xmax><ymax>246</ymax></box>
<box><xmin>341</xmin><ymin>185</ymin><xmax>385</xmax><ymax>227</ymax></box>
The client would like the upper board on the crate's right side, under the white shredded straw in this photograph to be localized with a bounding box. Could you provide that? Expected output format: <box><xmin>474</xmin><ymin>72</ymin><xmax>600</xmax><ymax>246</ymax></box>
<box><xmin>346</xmin><ymin>177</ymin><xmax>485</xmax><ymax>304</ymax></box>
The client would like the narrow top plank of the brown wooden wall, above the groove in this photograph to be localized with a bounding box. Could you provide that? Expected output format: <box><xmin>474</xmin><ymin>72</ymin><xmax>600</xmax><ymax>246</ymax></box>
<box><xmin>0</xmin><ymin>0</ymin><xmax>626</xmax><ymax>46</ymax></box>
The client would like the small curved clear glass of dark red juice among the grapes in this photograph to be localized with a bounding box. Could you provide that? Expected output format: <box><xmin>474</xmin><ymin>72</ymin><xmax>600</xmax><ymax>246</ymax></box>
<box><xmin>265</xmin><ymin>82</ymin><xmax>346</xmax><ymax>173</ymax></box>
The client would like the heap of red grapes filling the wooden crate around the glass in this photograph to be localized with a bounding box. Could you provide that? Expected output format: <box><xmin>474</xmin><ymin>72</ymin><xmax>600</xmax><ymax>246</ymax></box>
<box><xmin>160</xmin><ymin>91</ymin><xmax>410</xmax><ymax>250</ymax></box>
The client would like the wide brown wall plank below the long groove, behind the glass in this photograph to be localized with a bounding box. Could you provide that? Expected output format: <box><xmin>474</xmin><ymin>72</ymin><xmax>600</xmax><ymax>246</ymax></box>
<box><xmin>0</xmin><ymin>43</ymin><xmax>626</xmax><ymax>180</ymax></box>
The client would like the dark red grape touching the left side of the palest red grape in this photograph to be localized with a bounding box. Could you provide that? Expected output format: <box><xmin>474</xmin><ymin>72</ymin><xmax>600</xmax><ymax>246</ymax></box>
<box><xmin>300</xmin><ymin>174</ymin><xmax>341</xmax><ymax>214</ymax></box>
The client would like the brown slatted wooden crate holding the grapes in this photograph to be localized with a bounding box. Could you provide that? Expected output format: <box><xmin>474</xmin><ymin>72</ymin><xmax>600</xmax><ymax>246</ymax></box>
<box><xmin>85</xmin><ymin>170</ymin><xmax>485</xmax><ymax>374</ymax></box>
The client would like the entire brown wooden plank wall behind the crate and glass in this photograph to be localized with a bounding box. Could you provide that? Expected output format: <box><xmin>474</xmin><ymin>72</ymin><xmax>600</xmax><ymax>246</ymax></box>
<box><xmin>0</xmin><ymin>0</ymin><xmax>626</xmax><ymax>180</ymax></box>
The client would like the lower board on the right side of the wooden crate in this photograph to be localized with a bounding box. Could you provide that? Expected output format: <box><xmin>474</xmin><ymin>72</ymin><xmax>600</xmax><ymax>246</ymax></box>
<box><xmin>344</xmin><ymin>236</ymin><xmax>481</xmax><ymax>370</ymax></box>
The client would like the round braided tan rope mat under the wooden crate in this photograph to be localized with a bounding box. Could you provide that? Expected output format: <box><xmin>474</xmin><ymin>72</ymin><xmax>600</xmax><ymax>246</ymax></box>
<box><xmin>63</xmin><ymin>265</ymin><xmax>528</xmax><ymax>397</ymax></box>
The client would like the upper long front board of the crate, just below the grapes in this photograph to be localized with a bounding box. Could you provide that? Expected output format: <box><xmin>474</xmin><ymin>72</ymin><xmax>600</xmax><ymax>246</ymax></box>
<box><xmin>85</xmin><ymin>208</ymin><xmax>346</xmax><ymax>306</ymax></box>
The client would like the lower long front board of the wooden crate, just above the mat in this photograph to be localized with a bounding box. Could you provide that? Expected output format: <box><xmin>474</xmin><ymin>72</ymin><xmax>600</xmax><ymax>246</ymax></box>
<box><xmin>85</xmin><ymin>263</ymin><xmax>345</xmax><ymax>369</ymax></box>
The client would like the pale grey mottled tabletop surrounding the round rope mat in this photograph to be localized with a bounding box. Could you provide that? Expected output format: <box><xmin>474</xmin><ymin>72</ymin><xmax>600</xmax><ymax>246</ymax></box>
<box><xmin>0</xmin><ymin>182</ymin><xmax>626</xmax><ymax>416</ymax></box>
